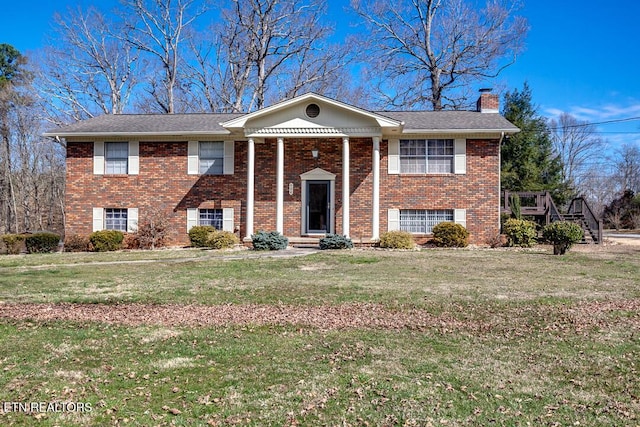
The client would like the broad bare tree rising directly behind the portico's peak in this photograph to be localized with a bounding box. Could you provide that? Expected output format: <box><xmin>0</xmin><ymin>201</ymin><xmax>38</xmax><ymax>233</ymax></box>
<box><xmin>185</xmin><ymin>0</ymin><xmax>353</xmax><ymax>112</ymax></box>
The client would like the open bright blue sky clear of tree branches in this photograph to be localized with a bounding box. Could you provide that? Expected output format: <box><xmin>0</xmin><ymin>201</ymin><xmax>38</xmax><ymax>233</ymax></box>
<box><xmin>0</xmin><ymin>0</ymin><xmax>640</xmax><ymax>147</ymax></box>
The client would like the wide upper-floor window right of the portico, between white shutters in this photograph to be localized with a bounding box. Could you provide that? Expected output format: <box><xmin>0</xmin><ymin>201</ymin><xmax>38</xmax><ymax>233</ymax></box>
<box><xmin>400</xmin><ymin>139</ymin><xmax>454</xmax><ymax>173</ymax></box>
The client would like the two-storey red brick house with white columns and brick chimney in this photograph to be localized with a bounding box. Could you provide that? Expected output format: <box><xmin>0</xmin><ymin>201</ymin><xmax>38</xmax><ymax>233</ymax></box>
<box><xmin>46</xmin><ymin>92</ymin><xmax>518</xmax><ymax>244</ymax></box>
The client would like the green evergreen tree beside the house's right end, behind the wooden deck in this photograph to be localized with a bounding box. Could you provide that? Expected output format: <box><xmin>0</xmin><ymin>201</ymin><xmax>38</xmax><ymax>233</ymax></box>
<box><xmin>500</xmin><ymin>83</ymin><xmax>572</xmax><ymax>204</ymax></box>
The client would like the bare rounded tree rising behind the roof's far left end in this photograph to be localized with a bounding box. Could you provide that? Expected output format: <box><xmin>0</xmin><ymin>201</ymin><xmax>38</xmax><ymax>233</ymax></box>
<box><xmin>38</xmin><ymin>7</ymin><xmax>139</xmax><ymax>125</ymax></box>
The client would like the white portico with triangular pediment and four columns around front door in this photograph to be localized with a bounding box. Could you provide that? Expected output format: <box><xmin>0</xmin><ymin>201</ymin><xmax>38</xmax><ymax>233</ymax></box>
<box><xmin>222</xmin><ymin>94</ymin><xmax>402</xmax><ymax>240</ymax></box>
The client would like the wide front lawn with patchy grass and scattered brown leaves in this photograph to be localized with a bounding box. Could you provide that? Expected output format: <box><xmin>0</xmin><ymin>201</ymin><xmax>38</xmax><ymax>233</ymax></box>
<box><xmin>0</xmin><ymin>246</ymin><xmax>640</xmax><ymax>426</ymax></box>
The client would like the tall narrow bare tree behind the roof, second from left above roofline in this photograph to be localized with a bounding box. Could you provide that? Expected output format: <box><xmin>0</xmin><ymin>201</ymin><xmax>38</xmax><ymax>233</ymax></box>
<box><xmin>123</xmin><ymin>0</ymin><xmax>206</xmax><ymax>114</ymax></box>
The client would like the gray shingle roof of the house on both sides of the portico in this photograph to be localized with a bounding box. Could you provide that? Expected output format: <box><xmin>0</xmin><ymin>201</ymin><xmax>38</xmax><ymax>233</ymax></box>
<box><xmin>45</xmin><ymin>111</ymin><xmax>518</xmax><ymax>137</ymax></box>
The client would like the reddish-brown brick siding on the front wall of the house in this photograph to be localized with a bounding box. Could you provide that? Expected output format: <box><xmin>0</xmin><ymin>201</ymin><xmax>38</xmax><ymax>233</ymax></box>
<box><xmin>65</xmin><ymin>138</ymin><xmax>499</xmax><ymax>244</ymax></box>
